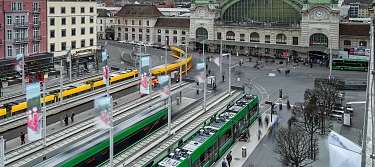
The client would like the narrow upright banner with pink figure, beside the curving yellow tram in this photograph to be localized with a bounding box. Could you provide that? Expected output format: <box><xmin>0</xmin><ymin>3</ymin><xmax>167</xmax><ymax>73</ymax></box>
<box><xmin>139</xmin><ymin>56</ymin><xmax>151</xmax><ymax>94</ymax></box>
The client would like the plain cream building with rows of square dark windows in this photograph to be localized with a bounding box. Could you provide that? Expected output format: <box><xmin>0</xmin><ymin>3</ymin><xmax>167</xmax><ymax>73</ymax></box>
<box><xmin>47</xmin><ymin>0</ymin><xmax>97</xmax><ymax>57</ymax></box>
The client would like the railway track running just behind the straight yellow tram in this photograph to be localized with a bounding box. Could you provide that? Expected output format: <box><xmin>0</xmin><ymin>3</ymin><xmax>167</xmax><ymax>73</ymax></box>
<box><xmin>0</xmin><ymin>71</ymin><xmax>101</xmax><ymax>105</ymax></box>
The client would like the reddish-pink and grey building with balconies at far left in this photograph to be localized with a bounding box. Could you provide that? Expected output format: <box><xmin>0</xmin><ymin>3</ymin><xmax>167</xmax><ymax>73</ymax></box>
<box><xmin>0</xmin><ymin>0</ymin><xmax>47</xmax><ymax>59</ymax></box>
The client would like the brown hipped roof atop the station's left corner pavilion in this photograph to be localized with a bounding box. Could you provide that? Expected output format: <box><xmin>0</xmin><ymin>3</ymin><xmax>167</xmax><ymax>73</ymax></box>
<box><xmin>115</xmin><ymin>4</ymin><xmax>163</xmax><ymax>17</ymax></box>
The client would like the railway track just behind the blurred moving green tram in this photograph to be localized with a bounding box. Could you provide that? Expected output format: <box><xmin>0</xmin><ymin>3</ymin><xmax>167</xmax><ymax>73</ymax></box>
<box><xmin>5</xmin><ymin>83</ymin><xmax>189</xmax><ymax>166</ymax></box>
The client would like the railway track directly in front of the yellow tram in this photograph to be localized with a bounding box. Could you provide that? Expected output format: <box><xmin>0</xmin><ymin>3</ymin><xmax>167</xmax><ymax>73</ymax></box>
<box><xmin>0</xmin><ymin>78</ymin><xmax>139</xmax><ymax>137</ymax></box>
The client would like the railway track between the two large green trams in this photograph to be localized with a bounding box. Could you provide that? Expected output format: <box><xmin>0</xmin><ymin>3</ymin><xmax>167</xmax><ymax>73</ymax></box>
<box><xmin>102</xmin><ymin>91</ymin><xmax>240</xmax><ymax>167</ymax></box>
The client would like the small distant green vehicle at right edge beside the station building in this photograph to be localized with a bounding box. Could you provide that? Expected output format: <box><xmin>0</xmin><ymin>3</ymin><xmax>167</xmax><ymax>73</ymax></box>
<box><xmin>332</xmin><ymin>58</ymin><xmax>368</xmax><ymax>71</ymax></box>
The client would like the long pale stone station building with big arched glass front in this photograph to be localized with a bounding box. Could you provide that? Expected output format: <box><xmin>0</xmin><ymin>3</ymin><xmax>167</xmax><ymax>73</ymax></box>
<box><xmin>115</xmin><ymin>0</ymin><xmax>372</xmax><ymax>57</ymax></box>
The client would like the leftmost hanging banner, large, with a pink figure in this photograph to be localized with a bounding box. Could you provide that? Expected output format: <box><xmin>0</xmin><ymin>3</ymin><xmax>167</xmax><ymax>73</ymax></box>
<box><xmin>26</xmin><ymin>83</ymin><xmax>42</xmax><ymax>141</ymax></box>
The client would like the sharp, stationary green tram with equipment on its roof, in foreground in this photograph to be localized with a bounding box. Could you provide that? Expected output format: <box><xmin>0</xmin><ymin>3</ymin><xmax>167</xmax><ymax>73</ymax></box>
<box><xmin>157</xmin><ymin>95</ymin><xmax>260</xmax><ymax>167</ymax></box>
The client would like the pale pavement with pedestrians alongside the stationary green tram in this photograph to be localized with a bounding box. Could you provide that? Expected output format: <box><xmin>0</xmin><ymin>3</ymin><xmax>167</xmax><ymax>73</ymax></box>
<box><xmin>214</xmin><ymin>111</ymin><xmax>277</xmax><ymax>167</ymax></box>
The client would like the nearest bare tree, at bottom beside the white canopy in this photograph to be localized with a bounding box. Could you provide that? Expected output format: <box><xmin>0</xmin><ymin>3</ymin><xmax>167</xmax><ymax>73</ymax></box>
<box><xmin>275</xmin><ymin>127</ymin><xmax>313</xmax><ymax>167</ymax></box>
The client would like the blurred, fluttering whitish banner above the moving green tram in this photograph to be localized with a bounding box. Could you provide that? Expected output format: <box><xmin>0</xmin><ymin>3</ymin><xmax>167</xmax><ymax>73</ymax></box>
<box><xmin>94</xmin><ymin>96</ymin><xmax>112</xmax><ymax>129</ymax></box>
